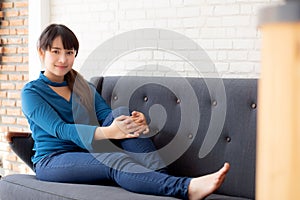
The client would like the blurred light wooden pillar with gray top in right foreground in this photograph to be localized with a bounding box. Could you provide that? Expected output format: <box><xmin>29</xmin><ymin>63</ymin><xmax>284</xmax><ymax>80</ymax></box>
<box><xmin>256</xmin><ymin>1</ymin><xmax>300</xmax><ymax>200</ymax></box>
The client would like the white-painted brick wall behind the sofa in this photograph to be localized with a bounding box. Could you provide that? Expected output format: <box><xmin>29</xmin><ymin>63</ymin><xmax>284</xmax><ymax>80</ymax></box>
<box><xmin>50</xmin><ymin>0</ymin><xmax>282</xmax><ymax>78</ymax></box>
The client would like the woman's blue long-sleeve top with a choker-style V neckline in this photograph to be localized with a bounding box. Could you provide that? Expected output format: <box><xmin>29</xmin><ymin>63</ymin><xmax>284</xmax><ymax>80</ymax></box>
<box><xmin>21</xmin><ymin>72</ymin><xmax>111</xmax><ymax>164</ymax></box>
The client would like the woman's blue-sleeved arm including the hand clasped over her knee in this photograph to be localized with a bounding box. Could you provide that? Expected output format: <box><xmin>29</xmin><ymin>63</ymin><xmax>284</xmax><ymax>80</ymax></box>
<box><xmin>22</xmin><ymin>88</ymin><xmax>140</xmax><ymax>150</ymax></box>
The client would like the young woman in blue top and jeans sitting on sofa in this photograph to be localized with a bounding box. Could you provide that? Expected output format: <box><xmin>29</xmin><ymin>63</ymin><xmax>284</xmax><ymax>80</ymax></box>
<box><xmin>22</xmin><ymin>24</ymin><xmax>229</xmax><ymax>200</ymax></box>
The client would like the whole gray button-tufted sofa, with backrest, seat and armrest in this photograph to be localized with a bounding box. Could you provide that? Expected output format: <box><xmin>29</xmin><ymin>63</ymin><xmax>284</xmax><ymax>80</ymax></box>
<box><xmin>0</xmin><ymin>77</ymin><xmax>257</xmax><ymax>200</ymax></box>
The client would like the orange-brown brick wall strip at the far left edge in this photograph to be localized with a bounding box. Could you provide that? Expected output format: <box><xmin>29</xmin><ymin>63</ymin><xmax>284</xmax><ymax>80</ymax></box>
<box><xmin>0</xmin><ymin>0</ymin><xmax>31</xmax><ymax>176</ymax></box>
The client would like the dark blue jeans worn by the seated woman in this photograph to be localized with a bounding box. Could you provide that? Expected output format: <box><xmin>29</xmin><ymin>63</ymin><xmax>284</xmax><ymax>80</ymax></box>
<box><xmin>35</xmin><ymin>109</ymin><xmax>191</xmax><ymax>199</ymax></box>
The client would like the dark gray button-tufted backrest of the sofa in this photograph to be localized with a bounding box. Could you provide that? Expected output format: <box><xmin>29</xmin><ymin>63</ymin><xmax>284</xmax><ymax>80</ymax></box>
<box><xmin>92</xmin><ymin>76</ymin><xmax>257</xmax><ymax>199</ymax></box>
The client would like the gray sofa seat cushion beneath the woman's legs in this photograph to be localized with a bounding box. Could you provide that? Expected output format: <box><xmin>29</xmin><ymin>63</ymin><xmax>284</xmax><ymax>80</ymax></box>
<box><xmin>0</xmin><ymin>174</ymin><xmax>253</xmax><ymax>200</ymax></box>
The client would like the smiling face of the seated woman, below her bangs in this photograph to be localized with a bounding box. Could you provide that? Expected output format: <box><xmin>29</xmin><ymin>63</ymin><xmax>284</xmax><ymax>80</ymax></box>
<box><xmin>39</xmin><ymin>36</ymin><xmax>76</xmax><ymax>82</ymax></box>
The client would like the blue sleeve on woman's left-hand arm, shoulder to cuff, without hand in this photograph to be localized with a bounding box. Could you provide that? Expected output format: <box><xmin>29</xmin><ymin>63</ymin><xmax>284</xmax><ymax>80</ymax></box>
<box><xmin>22</xmin><ymin>88</ymin><xmax>97</xmax><ymax>150</ymax></box>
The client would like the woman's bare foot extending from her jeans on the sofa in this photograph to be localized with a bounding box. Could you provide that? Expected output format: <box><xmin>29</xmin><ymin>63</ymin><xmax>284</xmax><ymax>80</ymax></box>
<box><xmin>188</xmin><ymin>163</ymin><xmax>230</xmax><ymax>200</ymax></box>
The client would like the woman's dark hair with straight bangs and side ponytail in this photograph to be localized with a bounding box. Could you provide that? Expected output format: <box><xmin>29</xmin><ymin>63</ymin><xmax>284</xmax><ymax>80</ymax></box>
<box><xmin>37</xmin><ymin>24</ymin><xmax>94</xmax><ymax>111</ymax></box>
